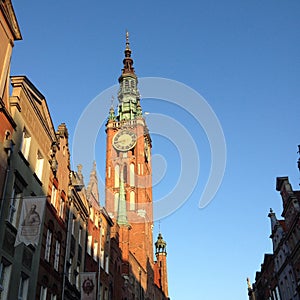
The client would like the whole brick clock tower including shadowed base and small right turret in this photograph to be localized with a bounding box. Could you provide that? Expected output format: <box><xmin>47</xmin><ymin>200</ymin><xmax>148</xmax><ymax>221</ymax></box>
<box><xmin>105</xmin><ymin>32</ymin><xmax>168</xmax><ymax>300</ymax></box>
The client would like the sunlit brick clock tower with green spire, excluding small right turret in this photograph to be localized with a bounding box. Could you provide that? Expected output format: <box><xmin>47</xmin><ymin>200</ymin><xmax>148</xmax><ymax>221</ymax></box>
<box><xmin>105</xmin><ymin>32</ymin><xmax>153</xmax><ymax>270</ymax></box>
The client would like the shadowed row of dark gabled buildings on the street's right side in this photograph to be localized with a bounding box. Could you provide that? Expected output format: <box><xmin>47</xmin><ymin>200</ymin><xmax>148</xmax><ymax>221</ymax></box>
<box><xmin>248</xmin><ymin>170</ymin><xmax>300</xmax><ymax>300</ymax></box>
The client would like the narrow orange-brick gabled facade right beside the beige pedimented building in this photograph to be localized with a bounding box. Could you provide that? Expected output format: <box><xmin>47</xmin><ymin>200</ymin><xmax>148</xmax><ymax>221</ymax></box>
<box><xmin>36</xmin><ymin>124</ymin><xmax>70</xmax><ymax>299</ymax></box>
